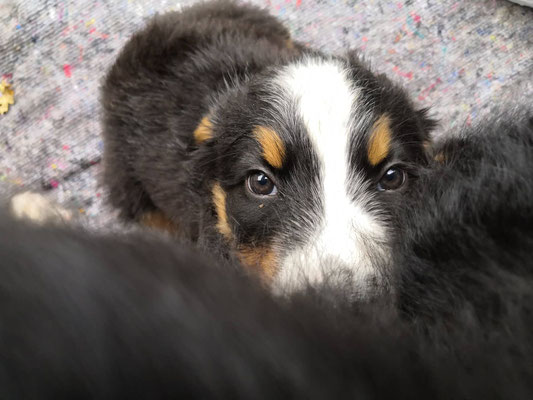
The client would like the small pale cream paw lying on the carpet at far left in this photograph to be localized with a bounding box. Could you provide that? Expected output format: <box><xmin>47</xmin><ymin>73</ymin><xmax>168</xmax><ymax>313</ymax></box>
<box><xmin>9</xmin><ymin>192</ymin><xmax>72</xmax><ymax>224</ymax></box>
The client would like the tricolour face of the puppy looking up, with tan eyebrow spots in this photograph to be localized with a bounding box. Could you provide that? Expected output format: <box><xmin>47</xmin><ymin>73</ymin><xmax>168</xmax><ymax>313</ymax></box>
<box><xmin>195</xmin><ymin>58</ymin><xmax>430</xmax><ymax>293</ymax></box>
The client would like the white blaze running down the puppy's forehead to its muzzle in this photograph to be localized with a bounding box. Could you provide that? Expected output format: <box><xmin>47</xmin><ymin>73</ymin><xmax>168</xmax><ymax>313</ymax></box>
<box><xmin>274</xmin><ymin>59</ymin><xmax>386</xmax><ymax>292</ymax></box>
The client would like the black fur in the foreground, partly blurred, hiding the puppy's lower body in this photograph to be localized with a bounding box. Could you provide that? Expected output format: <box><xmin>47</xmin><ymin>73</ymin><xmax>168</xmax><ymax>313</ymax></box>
<box><xmin>0</xmin><ymin>113</ymin><xmax>533</xmax><ymax>399</ymax></box>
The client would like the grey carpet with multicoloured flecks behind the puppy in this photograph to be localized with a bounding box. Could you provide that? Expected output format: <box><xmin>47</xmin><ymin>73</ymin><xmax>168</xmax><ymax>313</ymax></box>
<box><xmin>0</xmin><ymin>0</ymin><xmax>533</xmax><ymax>229</ymax></box>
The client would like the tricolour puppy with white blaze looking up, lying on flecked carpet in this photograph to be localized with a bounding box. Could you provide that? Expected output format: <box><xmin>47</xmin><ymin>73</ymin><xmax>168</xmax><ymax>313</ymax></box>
<box><xmin>102</xmin><ymin>1</ymin><xmax>434</xmax><ymax>295</ymax></box>
